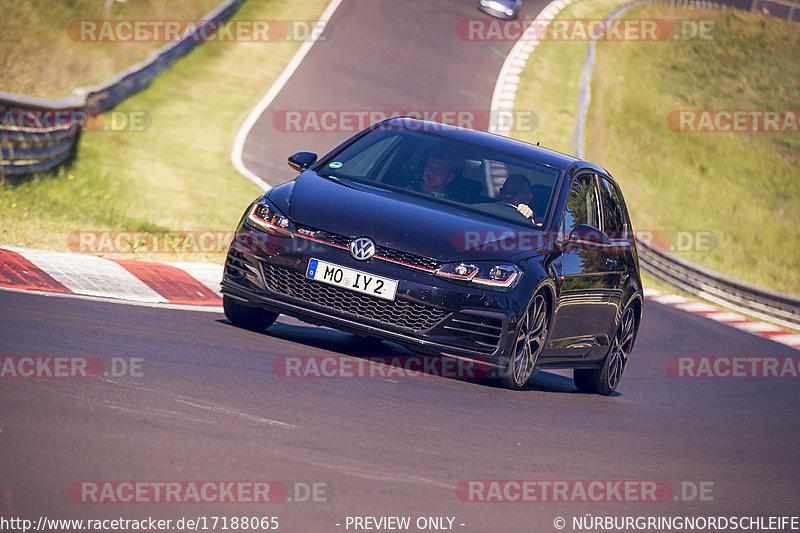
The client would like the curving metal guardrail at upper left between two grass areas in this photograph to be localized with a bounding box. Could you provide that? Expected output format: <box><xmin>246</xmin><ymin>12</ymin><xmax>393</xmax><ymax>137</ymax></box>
<box><xmin>0</xmin><ymin>0</ymin><xmax>244</xmax><ymax>179</ymax></box>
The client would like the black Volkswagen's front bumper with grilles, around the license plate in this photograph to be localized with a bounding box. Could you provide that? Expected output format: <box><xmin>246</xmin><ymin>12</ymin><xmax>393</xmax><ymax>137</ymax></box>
<box><xmin>222</xmin><ymin>225</ymin><xmax>516</xmax><ymax>366</ymax></box>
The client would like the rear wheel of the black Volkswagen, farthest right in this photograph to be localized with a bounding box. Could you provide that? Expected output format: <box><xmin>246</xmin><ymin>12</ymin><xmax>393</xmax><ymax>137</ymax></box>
<box><xmin>572</xmin><ymin>307</ymin><xmax>637</xmax><ymax>396</ymax></box>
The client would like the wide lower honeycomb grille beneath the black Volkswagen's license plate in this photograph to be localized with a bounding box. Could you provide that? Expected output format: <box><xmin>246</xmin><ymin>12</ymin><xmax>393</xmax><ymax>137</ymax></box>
<box><xmin>261</xmin><ymin>263</ymin><xmax>448</xmax><ymax>331</ymax></box>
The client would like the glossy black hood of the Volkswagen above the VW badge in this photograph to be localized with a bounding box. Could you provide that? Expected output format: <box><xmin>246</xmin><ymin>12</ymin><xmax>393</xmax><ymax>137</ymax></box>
<box><xmin>286</xmin><ymin>170</ymin><xmax>543</xmax><ymax>261</ymax></box>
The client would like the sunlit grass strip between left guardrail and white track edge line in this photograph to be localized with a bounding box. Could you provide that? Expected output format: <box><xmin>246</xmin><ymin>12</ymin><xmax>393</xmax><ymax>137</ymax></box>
<box><xmin>0</xmin><ymin>0</ymin><xmax>327</xmax><ymax>261</ymax></box>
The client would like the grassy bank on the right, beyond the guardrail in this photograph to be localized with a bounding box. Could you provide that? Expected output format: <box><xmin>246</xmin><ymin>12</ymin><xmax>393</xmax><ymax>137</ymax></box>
<box><xmin>586</xmin><ymin>6</ymin><xmax>800</xmax><ymax>294</ymax></box>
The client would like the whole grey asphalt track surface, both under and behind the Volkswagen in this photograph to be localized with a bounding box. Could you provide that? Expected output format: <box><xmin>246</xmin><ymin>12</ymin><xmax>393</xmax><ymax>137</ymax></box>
<box><xmin>0</xmin><ymin>0</ymin><xmax>800</xmax><ymax>533</ymax></box>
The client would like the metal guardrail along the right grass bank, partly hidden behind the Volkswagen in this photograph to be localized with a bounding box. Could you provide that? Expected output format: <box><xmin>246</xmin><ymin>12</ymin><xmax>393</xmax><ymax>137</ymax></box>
<box><xmin>572</xmin><ymin>0</ymin><xmax>800</xmax><ymax>330</ymax></box>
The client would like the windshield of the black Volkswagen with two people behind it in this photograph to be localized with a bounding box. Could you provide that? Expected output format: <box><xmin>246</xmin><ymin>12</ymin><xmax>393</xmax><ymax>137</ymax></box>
<box><xmin>316</xmin><ymin>126</ymin><xmax>560</xmax><ymax>225</ymax></box>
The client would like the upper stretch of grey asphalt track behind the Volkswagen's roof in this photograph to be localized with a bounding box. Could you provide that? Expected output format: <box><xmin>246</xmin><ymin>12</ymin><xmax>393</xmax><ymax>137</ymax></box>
<box><xmin>242</xmin><ymin>0</ymin><xmax>528</xmax><ymax>181</ymax></box>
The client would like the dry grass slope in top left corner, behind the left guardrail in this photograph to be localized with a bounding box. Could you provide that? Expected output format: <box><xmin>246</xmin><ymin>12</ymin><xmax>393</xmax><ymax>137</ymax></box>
<box><xmin>0</xmin><ymin>0</ymin><xmax>222</xmax><ymax>98</ymax></box>
